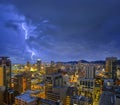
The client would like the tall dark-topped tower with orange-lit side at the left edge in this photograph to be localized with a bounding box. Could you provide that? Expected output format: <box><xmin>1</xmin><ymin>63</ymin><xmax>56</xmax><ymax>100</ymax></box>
<box><xmin>0</xmin><ymin>57</ymin><xmax>11</xmax><ymax>88</ymax></box>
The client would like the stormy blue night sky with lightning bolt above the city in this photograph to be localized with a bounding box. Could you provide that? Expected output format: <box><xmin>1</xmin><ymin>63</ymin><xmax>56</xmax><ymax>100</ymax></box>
<box><xmin>0</xmin><ymin>0</ymin><xmax>120</xmax><ymax>63</ymax></box>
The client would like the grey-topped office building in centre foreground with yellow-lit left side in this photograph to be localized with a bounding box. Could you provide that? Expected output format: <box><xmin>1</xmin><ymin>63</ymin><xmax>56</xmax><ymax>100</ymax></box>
<box><xmin>45</xmin><ymin>74</ymin><xmax>63</xmax><ymax>101</ymax></box>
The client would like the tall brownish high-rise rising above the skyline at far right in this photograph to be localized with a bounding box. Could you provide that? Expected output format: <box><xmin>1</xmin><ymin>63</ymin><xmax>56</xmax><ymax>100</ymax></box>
<box><xmin>106</xmin><ymin>57</ymin><xmax>117</xmax><ymax>79</ymax></box>
